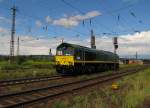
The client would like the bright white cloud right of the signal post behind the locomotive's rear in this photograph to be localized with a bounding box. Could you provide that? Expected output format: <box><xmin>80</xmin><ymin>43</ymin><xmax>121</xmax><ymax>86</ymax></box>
<box><xmin>118</xmin><ymin>31</ymin><xmax>150</xmax><ymax>55</ymax></box>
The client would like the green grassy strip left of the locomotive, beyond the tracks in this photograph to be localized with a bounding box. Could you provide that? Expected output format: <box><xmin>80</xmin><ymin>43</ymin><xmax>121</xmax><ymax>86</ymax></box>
<box><xmin>0</xmin><ymin>60</ymin><xmax>56</xmax><ymax>80</ymax></box>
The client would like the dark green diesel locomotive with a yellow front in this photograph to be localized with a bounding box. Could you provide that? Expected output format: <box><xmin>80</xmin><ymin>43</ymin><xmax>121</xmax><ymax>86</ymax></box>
<box><xmin>55</xmin><ymin>43</ymin><xmax>119</xmax><ymax>75</ymax></box>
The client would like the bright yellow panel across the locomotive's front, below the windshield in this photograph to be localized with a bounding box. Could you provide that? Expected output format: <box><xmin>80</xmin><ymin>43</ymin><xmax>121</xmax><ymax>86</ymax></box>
<box><xmin>55</xmin><ymin>56</ymin><xmax>74</xmax><ymax>66</ymax></box>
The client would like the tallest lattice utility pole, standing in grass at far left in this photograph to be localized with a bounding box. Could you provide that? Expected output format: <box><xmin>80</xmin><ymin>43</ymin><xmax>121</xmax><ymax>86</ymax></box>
<box><xmin>10</xmin><ymin>6</ymin><xmax>16</xmax><ymax>63</ymax></box>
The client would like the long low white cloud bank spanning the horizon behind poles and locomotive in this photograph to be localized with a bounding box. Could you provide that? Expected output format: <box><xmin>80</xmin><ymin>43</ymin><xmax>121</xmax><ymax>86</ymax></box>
<box><xmin>0</xmin><ymin>28</ymin><xmax>150</xmax><ymax>58</ymax></box>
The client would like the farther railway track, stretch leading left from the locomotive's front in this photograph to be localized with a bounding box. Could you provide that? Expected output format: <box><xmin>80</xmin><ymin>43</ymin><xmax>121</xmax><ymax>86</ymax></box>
<box><xmin>0</xmin><ymin>75</ymin><xmax>63</xmax><ymax>87</ymax></box>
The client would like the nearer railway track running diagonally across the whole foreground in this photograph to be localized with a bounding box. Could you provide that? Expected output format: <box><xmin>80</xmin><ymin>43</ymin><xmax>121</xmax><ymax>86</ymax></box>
<box><xmin>0</xmin><ymin>67</ymin><xmax>146</xmax><ymax>108</ymax></box>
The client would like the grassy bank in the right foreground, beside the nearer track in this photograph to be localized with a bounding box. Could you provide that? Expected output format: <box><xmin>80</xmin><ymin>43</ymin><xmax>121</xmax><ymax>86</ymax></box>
<box><xmin>53</xmin><ymin>69</ymin><xmax>150</xmax><ymax>108</ymax></box>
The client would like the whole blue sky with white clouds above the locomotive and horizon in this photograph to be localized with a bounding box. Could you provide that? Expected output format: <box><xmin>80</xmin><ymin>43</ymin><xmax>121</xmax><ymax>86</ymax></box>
<box><xmin>0</xmin><ymin>0</ymin><xmax>150</xmax><ymax>58</ymax></box>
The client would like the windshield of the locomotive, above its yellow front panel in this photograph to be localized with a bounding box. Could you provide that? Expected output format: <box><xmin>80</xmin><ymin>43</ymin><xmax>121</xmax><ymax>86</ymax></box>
<box><xmin>56</xmin><ymin>47</ymin><xmax>74</xmax><ymax>56</ymax></box>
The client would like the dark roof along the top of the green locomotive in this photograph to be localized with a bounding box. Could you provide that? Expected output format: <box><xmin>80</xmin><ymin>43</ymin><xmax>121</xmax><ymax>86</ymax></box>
<box><xmin>57</xmin><ymin>43</ymin><xmax>114</xmax><ymax>54</ymax></box>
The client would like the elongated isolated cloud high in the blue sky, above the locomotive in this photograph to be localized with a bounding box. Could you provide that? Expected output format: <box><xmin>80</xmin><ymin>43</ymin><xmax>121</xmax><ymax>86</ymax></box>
<box><xmin>46</xmin><ymin>11</ymin><xmax>101</xmax><ymax>28</ymax></box>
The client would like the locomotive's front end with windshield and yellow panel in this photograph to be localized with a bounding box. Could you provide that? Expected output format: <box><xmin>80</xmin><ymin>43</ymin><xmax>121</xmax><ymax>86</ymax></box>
<box><xmin>55</xmin><ymin>44</ymin><xmax>74</xmax><ymax>74</ymax></box>
